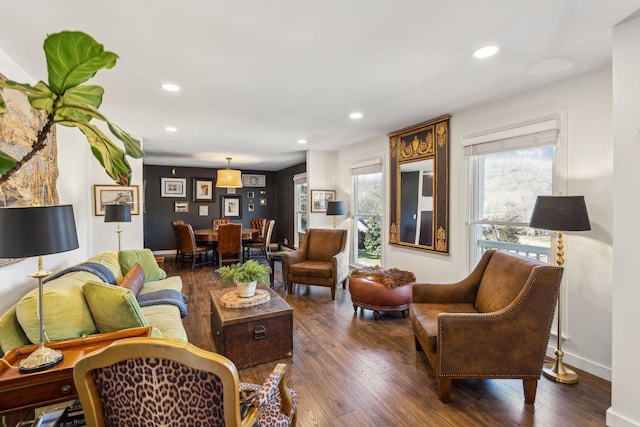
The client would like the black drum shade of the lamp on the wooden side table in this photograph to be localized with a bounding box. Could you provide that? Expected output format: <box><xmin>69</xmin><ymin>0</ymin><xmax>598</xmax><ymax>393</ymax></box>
<box><xmin>0</xmin><ymin>205</ymin><xmax>78</xmax><ymax>258</ymax></box>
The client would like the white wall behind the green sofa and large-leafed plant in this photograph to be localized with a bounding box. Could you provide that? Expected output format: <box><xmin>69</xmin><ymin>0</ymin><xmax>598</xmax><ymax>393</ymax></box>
<box><xmin>0</xmin><ymin>50</ymin><xmax>143</xmax><ymax>313</ymax></box>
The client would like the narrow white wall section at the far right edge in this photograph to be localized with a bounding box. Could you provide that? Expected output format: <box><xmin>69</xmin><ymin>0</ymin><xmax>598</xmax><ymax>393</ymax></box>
<box><xmin>607</xmin><ymin>15</ymin><xmax>640</xmax><ymax>427</ymax></box>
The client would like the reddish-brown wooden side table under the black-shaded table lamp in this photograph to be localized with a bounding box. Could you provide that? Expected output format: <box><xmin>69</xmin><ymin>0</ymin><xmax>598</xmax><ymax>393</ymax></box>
<box><xmin>0</xmin><ymin>327</ymin><xmax>151</xmax><ymax>415</ymax></box>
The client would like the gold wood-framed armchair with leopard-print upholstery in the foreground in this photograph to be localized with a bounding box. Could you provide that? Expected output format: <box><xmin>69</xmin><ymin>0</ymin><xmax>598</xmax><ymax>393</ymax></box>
<box><xmin>73</xmin><ymin>338</ymin><xmax>297</xmax><ymax>427</ymax></box>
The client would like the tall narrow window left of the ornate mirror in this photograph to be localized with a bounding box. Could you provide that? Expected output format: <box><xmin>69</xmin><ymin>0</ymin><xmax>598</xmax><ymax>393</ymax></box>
<box><xmin>351</xmin><ymin>159</ymin><xmax>384</xmax><ymax>265</ymax></box>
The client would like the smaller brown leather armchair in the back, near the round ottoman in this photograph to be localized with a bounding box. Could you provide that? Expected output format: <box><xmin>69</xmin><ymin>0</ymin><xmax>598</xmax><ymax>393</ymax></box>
<box><xmin>284</xmin><ymin>228</ymin><xmax>349</xmax><ymax>300</ymax></box>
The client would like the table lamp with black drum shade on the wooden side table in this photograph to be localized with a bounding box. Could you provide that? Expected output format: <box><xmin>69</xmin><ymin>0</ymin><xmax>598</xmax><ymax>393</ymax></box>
<box><xmin>0</xmin><ymin>205</ymin><xmax>78</xmax><ymax>372</ymax></box>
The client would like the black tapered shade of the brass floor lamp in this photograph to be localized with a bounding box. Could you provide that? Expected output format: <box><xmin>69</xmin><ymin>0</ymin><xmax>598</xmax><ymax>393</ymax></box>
<box><xmin>529</xmin><ymin>196</ymin><xmax>591</xmax><ymax>231</ymax></box>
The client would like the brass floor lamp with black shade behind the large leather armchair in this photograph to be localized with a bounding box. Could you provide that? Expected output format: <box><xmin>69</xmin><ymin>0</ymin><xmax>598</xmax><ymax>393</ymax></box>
<box><xmin>529</xmin><ymin>196</ymin><xmax>591</xmax><ymax>384</ymax></box>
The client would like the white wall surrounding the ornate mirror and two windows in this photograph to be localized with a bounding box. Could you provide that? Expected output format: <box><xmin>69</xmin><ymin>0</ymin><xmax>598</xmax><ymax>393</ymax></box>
<box><xmin>324</xmin><ymin>66</ymin><xmax>616</xmax><ymax>379</ymax></box>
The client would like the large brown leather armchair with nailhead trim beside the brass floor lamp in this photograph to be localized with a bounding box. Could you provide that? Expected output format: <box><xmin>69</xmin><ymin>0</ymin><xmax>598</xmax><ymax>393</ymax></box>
<box><xmin>409</xmin><ymin>250</ymin><xmax>563</xmax><ymax>403</ymax></box>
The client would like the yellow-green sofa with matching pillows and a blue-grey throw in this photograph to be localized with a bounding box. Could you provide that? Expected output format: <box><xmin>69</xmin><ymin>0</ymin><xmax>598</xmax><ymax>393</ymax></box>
<box><xmin>0</xmin><ymin>249</ymin><xmax>187</xmax><ymax>353</ymax></box>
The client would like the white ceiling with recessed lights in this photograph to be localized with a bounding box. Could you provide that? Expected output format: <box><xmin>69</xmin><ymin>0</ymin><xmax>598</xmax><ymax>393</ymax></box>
<box><xmin>0</xmin><ymin>0</ymin><xmax>640</xmax><ymax>171</ymax></box>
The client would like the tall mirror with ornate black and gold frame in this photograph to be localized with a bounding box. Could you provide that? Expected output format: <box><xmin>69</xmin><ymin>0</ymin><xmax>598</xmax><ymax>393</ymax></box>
<box><xmin>388</xmin><ymin>116</ymin><xmax>450</xmax><ymax>254</ymax></box>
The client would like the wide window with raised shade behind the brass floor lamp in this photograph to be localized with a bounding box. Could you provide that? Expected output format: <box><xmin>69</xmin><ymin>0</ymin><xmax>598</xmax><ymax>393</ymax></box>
<box><xmin>463</xmin><ymin>119</ymin><xmax>559</xmax><ymax>265</ymax></box>
